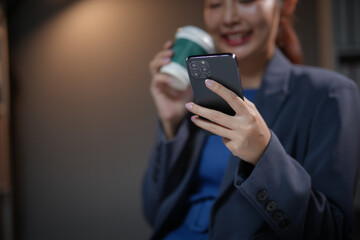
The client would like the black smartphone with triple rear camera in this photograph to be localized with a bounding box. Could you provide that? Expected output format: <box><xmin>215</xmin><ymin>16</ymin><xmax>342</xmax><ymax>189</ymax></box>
<box><xmin>186</xmin><ymin>53</ymin><xmax>244</xmax><ymax>115</ymax></box>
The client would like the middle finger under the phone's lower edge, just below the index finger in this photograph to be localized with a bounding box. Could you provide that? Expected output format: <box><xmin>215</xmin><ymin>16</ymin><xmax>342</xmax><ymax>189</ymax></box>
<box><xmin>185</xmin><ymin>102</ymin><xmax>235</xmax><ymax>129</ymax></box>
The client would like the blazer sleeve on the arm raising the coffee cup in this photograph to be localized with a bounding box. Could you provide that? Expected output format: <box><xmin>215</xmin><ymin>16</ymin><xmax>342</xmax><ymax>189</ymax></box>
<box><xmin>142</xmin><ymin>120</ymin><xmax>190</xmax><ymax>226</ymax></box>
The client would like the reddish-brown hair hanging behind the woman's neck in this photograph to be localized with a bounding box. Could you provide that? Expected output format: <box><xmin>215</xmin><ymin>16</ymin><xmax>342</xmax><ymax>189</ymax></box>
<box><xmin>276</xmin><ymin>0</ymin><xmax>302</xmax><ymax>64</ymax></box>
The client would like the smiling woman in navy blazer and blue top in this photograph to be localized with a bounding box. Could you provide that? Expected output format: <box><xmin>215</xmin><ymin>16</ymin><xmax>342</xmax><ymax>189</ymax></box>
<box><xmin>143</xmin><ymin>0</ymin><xmax>360</xmax><ymax>239</ymax></box>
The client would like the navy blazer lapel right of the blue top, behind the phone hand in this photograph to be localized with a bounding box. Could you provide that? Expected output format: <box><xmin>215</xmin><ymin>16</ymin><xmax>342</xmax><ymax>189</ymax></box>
<box><xmin>214</xmin><ymin>49</ymin><xmax>292</xmax><ymax>200</ymax></box>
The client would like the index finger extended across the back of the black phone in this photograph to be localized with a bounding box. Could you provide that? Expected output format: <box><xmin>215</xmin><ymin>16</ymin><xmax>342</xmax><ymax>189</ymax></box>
<box><xmin>205</xmin><ymin>79</ymin><xmax>246</xmax><ymax>113</ymax></box>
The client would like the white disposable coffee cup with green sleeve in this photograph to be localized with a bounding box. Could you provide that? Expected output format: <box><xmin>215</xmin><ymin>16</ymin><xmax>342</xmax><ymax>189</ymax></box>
<box><xmin>160</xmin><ymin>26</ymin><xmax>215</xmax><ymax>90</ymax></box>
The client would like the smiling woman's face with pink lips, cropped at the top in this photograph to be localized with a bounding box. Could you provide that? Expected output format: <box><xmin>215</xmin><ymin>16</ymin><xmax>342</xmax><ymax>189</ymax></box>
<box><xmin>204</xmin><ymin>0</ymin><xmax>280</xmax><ymax>61</ymax></box>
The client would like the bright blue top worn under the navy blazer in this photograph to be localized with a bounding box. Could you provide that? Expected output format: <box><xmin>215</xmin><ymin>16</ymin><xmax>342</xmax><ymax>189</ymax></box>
<box><xmin>165</xmin><ymin>89</ymin><xmax>257</xmax><ymax>240</ymax></box>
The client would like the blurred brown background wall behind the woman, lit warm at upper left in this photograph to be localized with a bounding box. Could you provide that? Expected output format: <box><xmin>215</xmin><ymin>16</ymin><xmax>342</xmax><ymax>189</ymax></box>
<box><xmin>0</xmin><ymin>0</ymin><xmax>360</xmax><ymax>240</ymax></box>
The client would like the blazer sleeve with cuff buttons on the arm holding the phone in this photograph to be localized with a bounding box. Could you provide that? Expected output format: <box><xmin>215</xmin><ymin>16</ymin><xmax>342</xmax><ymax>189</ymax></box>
<box><xmin>235</xmin><ymin>85</ymin><xmax>360</xmax><ymax>240</ymax></box>
